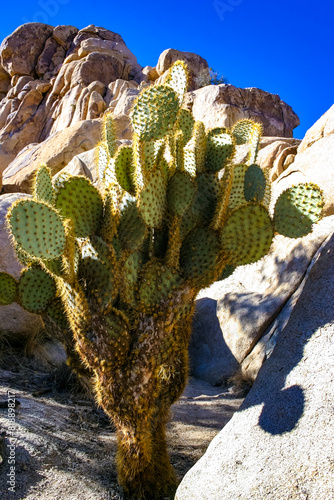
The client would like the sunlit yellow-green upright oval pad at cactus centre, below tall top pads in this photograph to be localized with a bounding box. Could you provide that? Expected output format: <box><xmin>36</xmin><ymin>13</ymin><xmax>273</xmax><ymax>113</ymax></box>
<box><xmin>139</xmin><ymin>169</ymin><xmax>166</xmax><ymax>227</ymax></box>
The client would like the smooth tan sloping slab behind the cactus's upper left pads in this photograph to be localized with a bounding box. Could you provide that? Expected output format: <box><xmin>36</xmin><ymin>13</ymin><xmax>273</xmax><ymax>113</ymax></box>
<box><xmin>3</xmin><ymin>120</ymin><xmax>101</xmax><ymax>193</ymax></box>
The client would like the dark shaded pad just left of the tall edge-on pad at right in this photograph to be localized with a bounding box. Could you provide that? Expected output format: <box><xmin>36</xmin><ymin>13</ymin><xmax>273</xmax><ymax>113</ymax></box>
<box><xmin>189</xmin><ymin>173</ymin><xmax>219</xmax><ymax>224</ymax></box>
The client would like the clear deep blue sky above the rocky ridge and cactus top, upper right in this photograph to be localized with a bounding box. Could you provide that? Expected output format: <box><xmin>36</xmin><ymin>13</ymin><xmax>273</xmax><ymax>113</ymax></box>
<box><xmin>0</xmin><ymin>0</ymin><xmax>334</xmax><ymax>138</ymax></box>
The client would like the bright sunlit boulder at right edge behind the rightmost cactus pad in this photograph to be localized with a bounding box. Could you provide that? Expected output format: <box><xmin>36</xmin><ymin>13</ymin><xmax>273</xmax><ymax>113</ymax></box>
<box><xmin>273</xmin><ymin>105</ymin><xmax>334</xmax><ymax>215</ymax></box>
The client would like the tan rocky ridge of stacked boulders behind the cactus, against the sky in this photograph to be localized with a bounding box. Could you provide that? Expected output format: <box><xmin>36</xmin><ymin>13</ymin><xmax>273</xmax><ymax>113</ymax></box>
<box><xmin>0</xmin><ymin>23</ymin><xmax>299</xmax><ymax>192</ymax></box>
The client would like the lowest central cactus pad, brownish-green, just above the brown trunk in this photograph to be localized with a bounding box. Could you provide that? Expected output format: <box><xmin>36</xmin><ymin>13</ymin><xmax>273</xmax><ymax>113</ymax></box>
<box><xmin>139</xmin><ymin>259</ymin><xmax>181</xmax><ymax>314</ymax></box>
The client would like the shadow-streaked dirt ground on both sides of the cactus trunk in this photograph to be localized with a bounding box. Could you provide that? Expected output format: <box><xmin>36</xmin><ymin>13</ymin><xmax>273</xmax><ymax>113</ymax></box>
<box><xmin>0</xmin><ymin>356</ymin><xmax>243</xmax><ymax>500</ymax></box>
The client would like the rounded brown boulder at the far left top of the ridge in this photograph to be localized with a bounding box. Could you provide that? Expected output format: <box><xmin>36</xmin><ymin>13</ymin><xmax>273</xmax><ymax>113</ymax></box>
<box><xmin>0</xmin><ymin>23</ymin><xmax>53</xmax><ymax>76</ymax></box>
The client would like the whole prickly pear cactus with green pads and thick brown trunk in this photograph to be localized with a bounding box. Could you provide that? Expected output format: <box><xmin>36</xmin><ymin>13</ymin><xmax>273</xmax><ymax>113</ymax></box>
<box><xmin>0</xmin><ymin>62</ymin><xmax>323</xmax><ymax>499</ymax></box>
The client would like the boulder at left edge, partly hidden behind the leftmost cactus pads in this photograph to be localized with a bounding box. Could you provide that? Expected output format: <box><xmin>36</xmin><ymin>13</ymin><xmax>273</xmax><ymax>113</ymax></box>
<box><xmin>0</xmin><ymin>194</ymin><xmax>43</xmax><ymax>337</ymax></box>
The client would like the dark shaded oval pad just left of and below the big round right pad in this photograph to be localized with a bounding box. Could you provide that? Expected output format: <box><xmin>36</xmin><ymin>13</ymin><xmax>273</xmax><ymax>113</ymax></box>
<box><xmin>180</xmin><ymin>227</ymin><xmax>219</xmax><ymax>287</ymax></box>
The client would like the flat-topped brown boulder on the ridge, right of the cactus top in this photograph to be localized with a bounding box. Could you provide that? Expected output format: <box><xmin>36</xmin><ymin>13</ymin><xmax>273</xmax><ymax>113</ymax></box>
<box><xmin>188</xmin><ymin>84</ymin><xmax>299</xmax><ymax>137</ymax></box>
